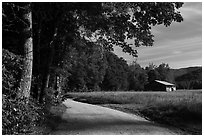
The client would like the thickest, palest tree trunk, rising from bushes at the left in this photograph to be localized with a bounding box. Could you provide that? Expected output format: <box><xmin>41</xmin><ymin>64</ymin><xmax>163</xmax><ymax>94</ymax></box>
<box><xmin>19</xmin><ymin>3</ymin><xmax>33</xmax><ymax>102</ymax></box>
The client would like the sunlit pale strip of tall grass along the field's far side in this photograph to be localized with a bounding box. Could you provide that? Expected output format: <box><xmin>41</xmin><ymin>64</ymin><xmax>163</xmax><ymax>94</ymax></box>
<box><xmin>66</xmin><ymin>91</ymin><xmax>202</xmax><ymax>108</ymax></box>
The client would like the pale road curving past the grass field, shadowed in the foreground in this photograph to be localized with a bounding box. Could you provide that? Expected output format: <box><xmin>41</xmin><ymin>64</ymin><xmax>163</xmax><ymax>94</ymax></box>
<box><xmin>51</xmin><ymin>99</ymin><xmax>182</xmax><ymax>135</ymax></box>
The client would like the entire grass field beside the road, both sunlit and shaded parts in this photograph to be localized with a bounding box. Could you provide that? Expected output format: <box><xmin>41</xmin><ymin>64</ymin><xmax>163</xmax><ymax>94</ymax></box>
<box><xmin>66</xmin><ymin>90</ymin><xmax>202</xmax><ymax>134</ymax></box>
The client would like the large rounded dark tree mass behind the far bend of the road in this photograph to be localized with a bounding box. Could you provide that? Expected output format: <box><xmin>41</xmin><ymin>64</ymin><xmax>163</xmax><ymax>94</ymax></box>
<box><xmin>62</xmin><ymin>39</ymin><xmax>107</xmax><ymax>91</ymax></box>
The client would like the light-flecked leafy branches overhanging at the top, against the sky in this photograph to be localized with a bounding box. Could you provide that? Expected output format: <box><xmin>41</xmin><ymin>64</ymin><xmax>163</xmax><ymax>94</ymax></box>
<box><xmin>76</xmin><ymin>2</ymin><xmax>183</xmax><ymax>56</ymax></box>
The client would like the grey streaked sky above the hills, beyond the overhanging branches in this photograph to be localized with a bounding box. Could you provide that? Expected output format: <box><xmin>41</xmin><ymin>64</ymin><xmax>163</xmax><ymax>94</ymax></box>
<box><xmin>114</xmin><ymin>2</ymin><xmax>202</xmax><ymax>69</ymax></box>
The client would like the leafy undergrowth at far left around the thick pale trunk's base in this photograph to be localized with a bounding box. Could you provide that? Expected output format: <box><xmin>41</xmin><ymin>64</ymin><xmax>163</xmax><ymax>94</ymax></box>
<box><xmin>2</xmin><ymin>49</ymin><xmax>44</xmax><ymax>135</ymax></box>
